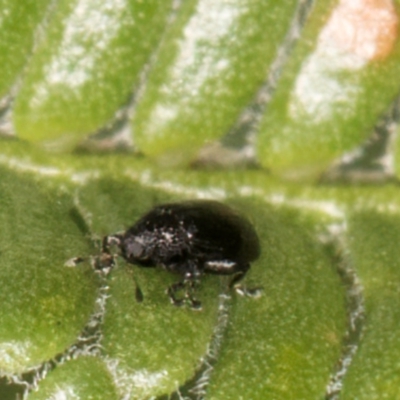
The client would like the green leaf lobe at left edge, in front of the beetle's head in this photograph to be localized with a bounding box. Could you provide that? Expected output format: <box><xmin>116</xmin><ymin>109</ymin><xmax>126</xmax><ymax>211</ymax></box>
<box><xmin>0</xmin><ymin>167</ymin><xmax>97</xmax><ymax>373</ymax></box>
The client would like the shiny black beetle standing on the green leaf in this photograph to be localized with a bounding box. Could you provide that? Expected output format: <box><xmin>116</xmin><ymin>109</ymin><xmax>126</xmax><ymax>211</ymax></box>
<box><xmin>69</xmin><ymin>200</ymin><xmax>260</xmax><ymax>309</ymax></box>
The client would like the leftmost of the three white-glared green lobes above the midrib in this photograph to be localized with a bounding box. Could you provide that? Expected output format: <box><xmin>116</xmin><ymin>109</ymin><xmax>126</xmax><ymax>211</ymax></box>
<box><xmin>15</xmin><ymin>0</ymin><xmax>171</xmax><ymax>141</ymax></box>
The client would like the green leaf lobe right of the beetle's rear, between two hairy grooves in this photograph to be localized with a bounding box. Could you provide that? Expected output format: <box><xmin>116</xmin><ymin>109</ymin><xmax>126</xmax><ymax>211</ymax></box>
<box><xmin>206</xmin><ymin>202</ymin><xmax>346</xmax><ymax>399</ymax></box>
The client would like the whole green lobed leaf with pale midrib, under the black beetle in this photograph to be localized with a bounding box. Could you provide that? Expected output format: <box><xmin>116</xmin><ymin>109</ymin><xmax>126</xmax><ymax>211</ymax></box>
<box><xmin>0</xmin><ymin>0</ymin><xmax>400</xmax><ymax>400</ymax></box>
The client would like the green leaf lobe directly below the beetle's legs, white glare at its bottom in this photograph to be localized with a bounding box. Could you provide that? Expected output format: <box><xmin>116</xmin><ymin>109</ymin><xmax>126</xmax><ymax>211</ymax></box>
<box><xmin>102</xmin><ymin>266</ymin><xmax>219</xmax><ymax>398</ymax></box>
